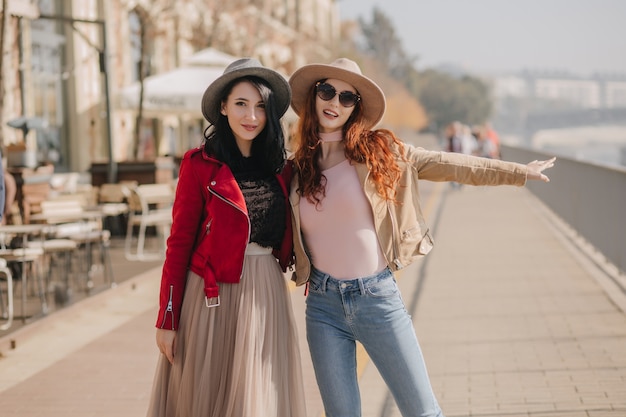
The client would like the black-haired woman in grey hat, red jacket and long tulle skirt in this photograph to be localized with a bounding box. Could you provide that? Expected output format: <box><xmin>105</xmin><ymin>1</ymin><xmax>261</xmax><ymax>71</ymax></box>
<box><xmin>148</xmin><ymin>58</ymin><xmax>306</xmax><ymax>417</ymax></box>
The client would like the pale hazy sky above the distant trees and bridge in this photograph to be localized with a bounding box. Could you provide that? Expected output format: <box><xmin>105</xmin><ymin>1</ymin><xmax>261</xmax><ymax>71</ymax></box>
<box><xmin>337</xmin><ymin>0</ymin><xmax>626</xmax><ymax>76</ymax></box>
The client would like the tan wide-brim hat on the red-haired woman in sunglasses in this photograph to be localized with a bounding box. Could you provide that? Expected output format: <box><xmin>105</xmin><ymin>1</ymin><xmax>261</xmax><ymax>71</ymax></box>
<box><xmin>289</xmin><ymin>58</ymin><xmax>386</xmax><ymax>129</ymax></box>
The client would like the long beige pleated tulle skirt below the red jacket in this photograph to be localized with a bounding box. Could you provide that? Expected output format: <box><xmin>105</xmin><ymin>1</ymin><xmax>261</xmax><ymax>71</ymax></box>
<box><xmin>148</xmin><ymin>244</ymin><xmax>306</xmax><ymax>417</ymax></box>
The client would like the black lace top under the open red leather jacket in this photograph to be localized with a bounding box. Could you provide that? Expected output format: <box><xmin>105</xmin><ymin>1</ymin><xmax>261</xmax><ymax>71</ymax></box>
<box><xmin>233</xmin><ymin>158</ymin><xmax>286</xmax><ymax>249</ymax></box>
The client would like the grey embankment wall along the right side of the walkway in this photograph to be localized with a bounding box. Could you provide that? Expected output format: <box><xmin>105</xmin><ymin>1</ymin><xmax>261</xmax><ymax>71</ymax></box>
<box><xmin>502</xmin><ymin>145</ymin><xmax>626</xmax><ymax>274</ymax></box>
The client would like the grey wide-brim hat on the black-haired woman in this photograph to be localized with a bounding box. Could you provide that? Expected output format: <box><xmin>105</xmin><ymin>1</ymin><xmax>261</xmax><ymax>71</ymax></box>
<box><xmin>202</xmin><ymin>58</ymin><xmax>291</xmax><ymax>125</ymax></box>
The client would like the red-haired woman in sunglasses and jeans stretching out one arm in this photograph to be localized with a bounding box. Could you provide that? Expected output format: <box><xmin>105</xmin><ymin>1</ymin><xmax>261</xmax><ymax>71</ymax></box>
<box><xmin>289</xmin><ymin>58</ymin><xmax>554</xmax><ymax>417</ymax></box>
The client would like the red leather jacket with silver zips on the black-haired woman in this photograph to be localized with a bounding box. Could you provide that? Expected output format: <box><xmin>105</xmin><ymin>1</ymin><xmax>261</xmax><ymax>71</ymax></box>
<box><xmin>156</xmin><ymin>148</ymin><xmax>293</xmax><ymax>330</ymax></box>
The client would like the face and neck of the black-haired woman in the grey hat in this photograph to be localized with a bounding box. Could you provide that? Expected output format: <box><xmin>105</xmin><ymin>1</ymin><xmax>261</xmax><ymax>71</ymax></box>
<box><xmin>221</xmin><ymin>81</ymin><xmax>267</xmax><ymax>156</ymax></box>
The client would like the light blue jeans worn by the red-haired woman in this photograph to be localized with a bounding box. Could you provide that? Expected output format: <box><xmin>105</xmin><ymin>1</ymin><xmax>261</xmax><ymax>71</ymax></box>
<box><xmin>306</xmin><ymin>268</ymin><xmax>443</xmax><ymax>417</ymax></box>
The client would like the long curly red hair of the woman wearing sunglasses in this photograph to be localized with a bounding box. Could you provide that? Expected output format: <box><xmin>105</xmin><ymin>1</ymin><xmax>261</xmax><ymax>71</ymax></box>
<box><xmin>294</xmin><ymin>81</ymin><xmax>404</xmax><ymax>204</ymax></box>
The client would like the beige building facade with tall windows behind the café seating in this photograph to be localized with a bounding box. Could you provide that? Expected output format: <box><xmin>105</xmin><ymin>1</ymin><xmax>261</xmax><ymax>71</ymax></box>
<box><xmin>1</xmin><ymin>0</ymin><xmax>339</xmax><ymax>172</ymax></box>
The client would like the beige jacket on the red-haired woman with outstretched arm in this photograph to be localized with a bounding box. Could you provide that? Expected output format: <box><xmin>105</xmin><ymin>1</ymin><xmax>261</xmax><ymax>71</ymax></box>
<box><xmin>289</xmin><ymin>144</ymin><xmax>528</xmax><ymax>286</ymax></box>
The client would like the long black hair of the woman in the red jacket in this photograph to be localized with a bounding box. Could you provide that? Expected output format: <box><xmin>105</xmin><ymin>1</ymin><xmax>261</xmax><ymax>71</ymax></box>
<box><xmin>204</xmin><ymin>76</ymin><xmax>287</xmax><ymax>173</ymax></box>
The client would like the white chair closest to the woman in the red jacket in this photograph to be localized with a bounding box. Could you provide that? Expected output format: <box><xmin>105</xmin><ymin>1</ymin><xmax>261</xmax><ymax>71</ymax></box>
<box><xmin>124</xmin><ymin>184</ymin><xmax>174</xmax><ymax>261</ymax></box>
